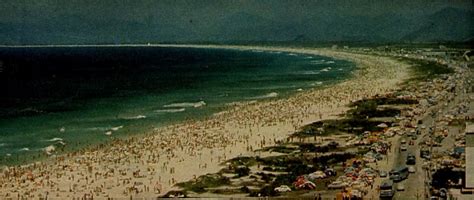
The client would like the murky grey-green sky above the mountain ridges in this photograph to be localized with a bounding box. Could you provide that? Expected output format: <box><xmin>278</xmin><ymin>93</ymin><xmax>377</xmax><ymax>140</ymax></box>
<box><xmin>0</xmin><ymin>0</ymin><xmax>472</xmax><ymax>23</ymax></box>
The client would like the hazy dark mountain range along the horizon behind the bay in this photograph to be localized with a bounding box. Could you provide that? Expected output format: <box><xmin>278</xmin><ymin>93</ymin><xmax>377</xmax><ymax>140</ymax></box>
<box><xmin>0</xmin><ymin>8</ymin><xmax>474</xmax><ymax>44</ymax></box>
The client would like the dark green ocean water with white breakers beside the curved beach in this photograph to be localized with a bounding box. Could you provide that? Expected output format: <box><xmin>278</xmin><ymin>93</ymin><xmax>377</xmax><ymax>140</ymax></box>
<box><xmin>0</xmin><ymin>47</ymin><xmax>354</xmax><ymax>165</ymax></box>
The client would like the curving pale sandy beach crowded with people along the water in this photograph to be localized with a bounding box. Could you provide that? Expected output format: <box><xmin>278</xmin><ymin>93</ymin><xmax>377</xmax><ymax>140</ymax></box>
<box><xmin>0</xmin><ymin>45</ymin><xmax>410</xmax><ymax>199</ymax></box>
